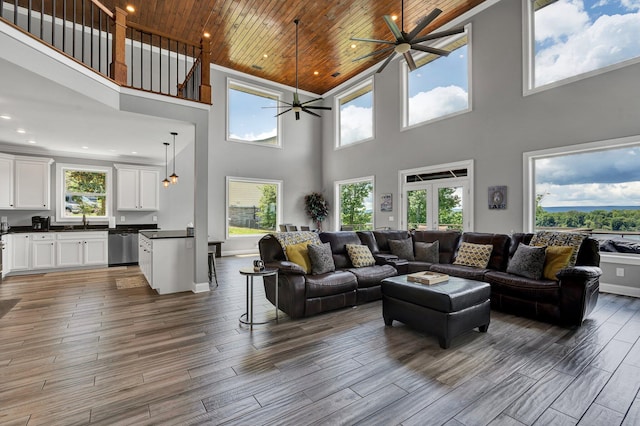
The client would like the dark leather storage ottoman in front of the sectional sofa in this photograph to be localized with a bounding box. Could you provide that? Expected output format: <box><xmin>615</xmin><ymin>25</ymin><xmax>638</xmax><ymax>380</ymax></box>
<box><xmin>382</xmin><ymin>275</ymin><xmax>491</xmax><ymax>349</ymax></box>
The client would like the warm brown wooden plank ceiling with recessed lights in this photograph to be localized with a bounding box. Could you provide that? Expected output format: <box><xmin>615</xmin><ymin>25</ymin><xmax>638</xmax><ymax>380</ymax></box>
<box><xmin>102</xmin><ymin>0</ymin><xmax>485</xmax><ymax>94</ymax></box>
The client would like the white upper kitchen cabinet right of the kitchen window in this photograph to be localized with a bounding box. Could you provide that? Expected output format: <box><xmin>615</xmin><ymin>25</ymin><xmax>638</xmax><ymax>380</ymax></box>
<box><xmin>114</xmin><ymin>164</ymin><xmax>160</xmax><ymax>211</ymax></box>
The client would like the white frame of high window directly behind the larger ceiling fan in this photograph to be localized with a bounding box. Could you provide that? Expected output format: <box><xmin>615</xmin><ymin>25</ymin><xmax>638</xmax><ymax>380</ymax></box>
<box><xmin>400</xmin><ymin>23</ymin><xmax>473</xmax><ymax>131</ymax></box>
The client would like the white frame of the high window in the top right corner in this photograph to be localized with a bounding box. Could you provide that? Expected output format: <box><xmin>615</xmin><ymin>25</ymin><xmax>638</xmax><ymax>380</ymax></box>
<box><xmin>522</xmin><ymin>0</ymin><xmax>640</xmax><ymax>96</ymax></box>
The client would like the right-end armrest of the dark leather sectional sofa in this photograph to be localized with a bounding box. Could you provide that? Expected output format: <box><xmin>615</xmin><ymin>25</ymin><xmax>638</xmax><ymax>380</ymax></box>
<box><xmin>556</xmin><ymin>266</ymin><xmax>602</xmax><ymax>326</ymax></box>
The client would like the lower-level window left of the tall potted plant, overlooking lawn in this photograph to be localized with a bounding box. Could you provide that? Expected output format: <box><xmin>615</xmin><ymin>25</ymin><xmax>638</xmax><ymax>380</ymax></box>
<box><xmin>227</xmin><ymin>177</ymin><xmax>282</xmax><ymax>237</ymax></box>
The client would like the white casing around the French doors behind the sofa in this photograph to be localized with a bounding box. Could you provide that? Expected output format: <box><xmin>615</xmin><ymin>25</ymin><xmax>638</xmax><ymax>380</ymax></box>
<box><xmin>398</xmin><ymin>160</ymin><xmax>475</xmax><ymax>232</ymax></box>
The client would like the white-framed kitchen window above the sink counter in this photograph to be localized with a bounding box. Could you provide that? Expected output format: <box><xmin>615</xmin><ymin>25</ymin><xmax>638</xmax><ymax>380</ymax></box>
<box><xmin>56</xmin><ymin>164</ymin><xmax>111</xmax><ymax>220</ymax></box>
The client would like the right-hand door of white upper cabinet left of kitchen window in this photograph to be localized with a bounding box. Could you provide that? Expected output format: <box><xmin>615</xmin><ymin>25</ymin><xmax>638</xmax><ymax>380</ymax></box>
<box><xmin>14</xmin><ymin>157</ymin><xmax>53</xmax><ymax>210</ymax></box>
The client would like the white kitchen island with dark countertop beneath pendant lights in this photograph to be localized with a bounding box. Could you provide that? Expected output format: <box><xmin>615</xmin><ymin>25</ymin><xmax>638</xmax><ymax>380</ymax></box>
<box><xmin>138</xmin><ymin>229</ymin><xmax>196</xmax><ymax>294</ymax></box>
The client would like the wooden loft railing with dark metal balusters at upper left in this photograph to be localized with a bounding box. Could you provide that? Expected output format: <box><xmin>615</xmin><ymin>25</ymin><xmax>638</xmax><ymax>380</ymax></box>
<box><xmin>0</xmin><ymin>0</ymin><xmax>211</xmax><ymax>103</ymax></box>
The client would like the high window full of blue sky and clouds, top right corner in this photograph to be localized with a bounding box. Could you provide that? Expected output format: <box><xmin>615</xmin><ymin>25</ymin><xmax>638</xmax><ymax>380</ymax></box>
<box><xmin>524</xmin><ymin>0</ymin><xmax>640</xmax><ymax>89</ymax></box>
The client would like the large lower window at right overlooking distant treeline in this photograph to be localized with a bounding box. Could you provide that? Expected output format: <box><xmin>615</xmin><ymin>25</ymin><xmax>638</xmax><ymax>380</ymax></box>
<box><xmin>525</xmin><ymin>137</ymin><xmax>640</xmax><ymax>241</ymax></box>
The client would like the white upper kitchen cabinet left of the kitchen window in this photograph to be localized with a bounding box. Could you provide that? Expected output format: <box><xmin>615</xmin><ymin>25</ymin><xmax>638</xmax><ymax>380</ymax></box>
<box><xmin>0</xmin><ymin>154</ymin><xmax>53</xmax><ymax>210</ymax></box>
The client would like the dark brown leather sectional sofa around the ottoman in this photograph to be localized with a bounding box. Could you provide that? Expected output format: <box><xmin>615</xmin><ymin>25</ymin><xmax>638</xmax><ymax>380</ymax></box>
<box><xmin>259</xmin><ymin>230</ymin><xmax>602</xmax><ymax>325</ymax></box>
